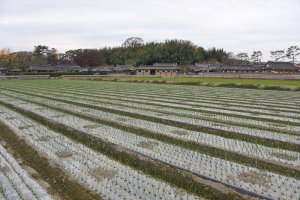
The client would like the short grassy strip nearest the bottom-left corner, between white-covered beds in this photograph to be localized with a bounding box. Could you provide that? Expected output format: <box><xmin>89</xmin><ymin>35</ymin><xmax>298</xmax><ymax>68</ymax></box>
<box><xmin>0</xmin><ymin>122</ymin><xmax>101</xmax><ymax>200</ymax></box>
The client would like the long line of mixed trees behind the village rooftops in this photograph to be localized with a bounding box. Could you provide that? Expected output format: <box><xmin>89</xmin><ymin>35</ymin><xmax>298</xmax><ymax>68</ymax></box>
<box><xmin>0</xmin><ymin>37</ymin><xmax>300</xmax><ymax>71</ymax></box>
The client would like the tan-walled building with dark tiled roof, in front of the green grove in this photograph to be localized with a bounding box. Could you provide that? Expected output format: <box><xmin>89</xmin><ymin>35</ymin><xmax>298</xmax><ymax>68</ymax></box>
<box><xmin>136</xmin><ymin>63</ymin><xmax>180</xmax><ymax>77</ymax></box>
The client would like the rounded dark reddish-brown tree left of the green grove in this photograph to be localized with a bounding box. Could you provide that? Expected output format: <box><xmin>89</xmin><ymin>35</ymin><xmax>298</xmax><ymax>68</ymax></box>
<box><xmin>74</xmin><ymin>49</ymin><xmax>105</xmax><ymax>74</ymax></box>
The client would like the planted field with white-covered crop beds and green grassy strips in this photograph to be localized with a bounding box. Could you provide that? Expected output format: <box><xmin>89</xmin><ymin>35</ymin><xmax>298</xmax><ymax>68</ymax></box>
<box><xmin>0</xmin><ymin>80</ymin><xmax>300</xmax><ymax>200</ymax></box>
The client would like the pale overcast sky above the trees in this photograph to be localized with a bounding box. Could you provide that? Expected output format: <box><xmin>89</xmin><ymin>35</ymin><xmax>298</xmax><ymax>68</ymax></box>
<box><xmin>0</xmin><ymin>0</ymin><xmax>300</xmax><ymax>58</ymax></box>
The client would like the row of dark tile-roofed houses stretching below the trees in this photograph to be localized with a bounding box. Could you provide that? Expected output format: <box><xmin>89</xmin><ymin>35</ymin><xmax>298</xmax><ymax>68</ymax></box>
<box><xmin>0</xmin><ymin>62</ymin><xmax>300</xmax><ymax>77</ymax></box>
